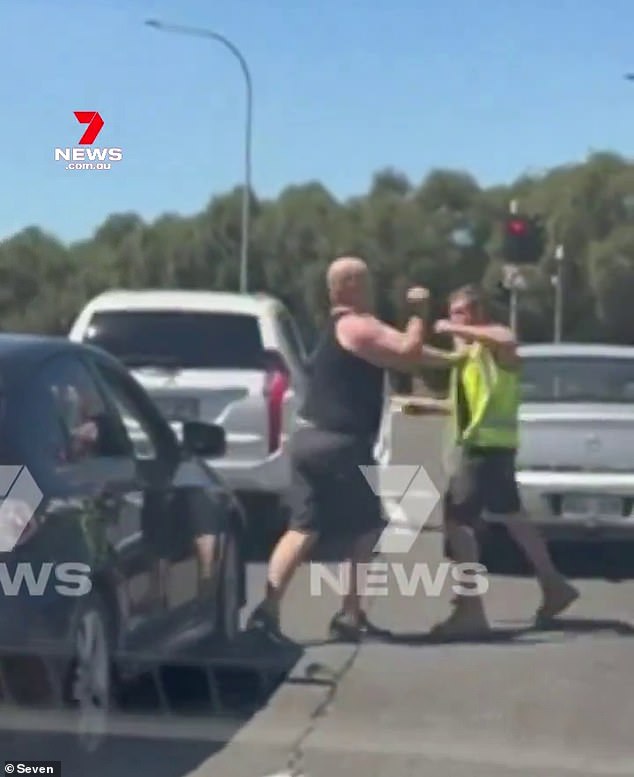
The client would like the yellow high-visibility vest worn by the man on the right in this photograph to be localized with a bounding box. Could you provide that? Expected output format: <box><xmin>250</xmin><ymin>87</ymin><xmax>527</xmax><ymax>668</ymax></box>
<box><xmin>450</xmin><ymin>343</ymin><xmax>520</xmax><ymax>448</ymax></box>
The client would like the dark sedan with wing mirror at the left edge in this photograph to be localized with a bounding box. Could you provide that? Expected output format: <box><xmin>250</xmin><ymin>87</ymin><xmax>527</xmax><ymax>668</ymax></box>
<box><xmin>0</xmin><ymin>335</ymin><xmax>245</xmax><ymax>748</ymax></box>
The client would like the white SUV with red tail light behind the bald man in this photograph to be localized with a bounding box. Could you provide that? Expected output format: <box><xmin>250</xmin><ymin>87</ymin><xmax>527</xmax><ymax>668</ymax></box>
<box><xmin>70</xmin><ymin>290</ymin><xmax>306</xmax><ymax>532</ymax></box>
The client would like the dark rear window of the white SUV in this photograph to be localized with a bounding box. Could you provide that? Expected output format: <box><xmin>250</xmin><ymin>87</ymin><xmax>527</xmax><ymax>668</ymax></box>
<box><xmin>84</xmin><ymin>310</ymin><xmax>263</xmax><ymax>370</ymax></box>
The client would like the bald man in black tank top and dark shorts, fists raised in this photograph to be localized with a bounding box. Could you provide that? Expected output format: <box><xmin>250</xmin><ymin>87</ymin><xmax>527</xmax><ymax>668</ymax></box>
<box><xmin>249</xmin><ymin>257</ymin><xmax>428</xmax><ymax>641</ymax></box>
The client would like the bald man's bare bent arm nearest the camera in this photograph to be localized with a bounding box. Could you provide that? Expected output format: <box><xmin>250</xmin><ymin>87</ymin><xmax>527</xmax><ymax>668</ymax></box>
<box><xmin>337</xmin><ymin>315</ymin><xmax>425</xmax><ymax>372</ymax></box>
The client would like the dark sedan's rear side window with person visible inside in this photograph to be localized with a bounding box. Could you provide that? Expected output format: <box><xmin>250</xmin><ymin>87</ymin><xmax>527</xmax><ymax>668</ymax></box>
<box><xmin>25</xmin><ymin>355</ymin><xmax>128</xmax><ymax>466</ymax></box>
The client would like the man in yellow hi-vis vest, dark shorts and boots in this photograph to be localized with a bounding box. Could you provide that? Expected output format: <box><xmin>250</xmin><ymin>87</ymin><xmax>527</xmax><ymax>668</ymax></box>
<box><xmin>423</xmin><ymin>286</ymin><xmax>579</xmax><ymax>636</ymax></box>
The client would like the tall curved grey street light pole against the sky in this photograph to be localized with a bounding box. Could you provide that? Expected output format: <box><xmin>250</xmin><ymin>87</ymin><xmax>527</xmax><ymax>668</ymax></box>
<box><xmin>145</xmin><ymin>19</ymin><xmax>253</xmax><ymax>294</ymax></box>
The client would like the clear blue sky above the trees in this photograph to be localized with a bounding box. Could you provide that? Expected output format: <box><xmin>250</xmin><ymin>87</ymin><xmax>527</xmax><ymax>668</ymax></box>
<box><xmin>0</xmin><ymin>0</ymin><xmax>634</xmax><ymax>241</ymax></box>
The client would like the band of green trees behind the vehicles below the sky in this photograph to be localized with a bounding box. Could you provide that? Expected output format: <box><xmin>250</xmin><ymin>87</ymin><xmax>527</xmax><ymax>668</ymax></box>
<box><xmin>0</xmin><ymin>153</ymin><xmax>634</xmax><ymax>343</ymax></box>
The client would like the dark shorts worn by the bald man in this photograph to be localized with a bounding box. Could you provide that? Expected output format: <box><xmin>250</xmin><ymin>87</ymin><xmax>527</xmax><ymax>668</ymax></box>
<box><xmin>288</xmin><ymin>427</ymin><xmax>386</xmax><ymax>542</ymax></box>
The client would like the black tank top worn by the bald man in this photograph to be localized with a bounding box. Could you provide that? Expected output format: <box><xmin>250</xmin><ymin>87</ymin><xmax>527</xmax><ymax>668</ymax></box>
<box><xmin>300</xmin><ymin>313</ymin><xmax>385</xmax><ymax>438</ymax></box>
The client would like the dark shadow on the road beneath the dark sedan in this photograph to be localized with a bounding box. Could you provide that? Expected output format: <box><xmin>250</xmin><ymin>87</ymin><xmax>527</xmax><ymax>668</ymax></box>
<box><xmin>0</xmin><ymin>635</ymin><xmax>304</xmax><ymax>777</ymax></box>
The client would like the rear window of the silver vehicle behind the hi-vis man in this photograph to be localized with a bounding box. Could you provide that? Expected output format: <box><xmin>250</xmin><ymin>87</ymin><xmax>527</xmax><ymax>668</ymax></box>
<box><xmin>521</xmin><ymin>356</ymin><xmax>634</xmax><ymax>402</ymax></box>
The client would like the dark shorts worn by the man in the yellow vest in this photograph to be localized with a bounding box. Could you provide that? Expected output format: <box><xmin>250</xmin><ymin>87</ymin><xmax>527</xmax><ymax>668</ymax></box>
<box><xmin>445</xmin><ymin>447</ymin><xmax>521</xmax><ymax>525</ymax></box>
